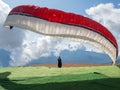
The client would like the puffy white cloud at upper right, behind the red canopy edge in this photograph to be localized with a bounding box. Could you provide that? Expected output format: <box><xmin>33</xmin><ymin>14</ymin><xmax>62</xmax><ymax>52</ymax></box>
<box><xmin>86</xmin><ymin>3</ymin><xmax>120</xmax><ymax>56</ymax></box>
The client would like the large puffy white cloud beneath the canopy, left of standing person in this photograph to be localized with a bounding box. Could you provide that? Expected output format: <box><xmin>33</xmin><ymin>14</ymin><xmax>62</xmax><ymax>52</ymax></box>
<box><xmin>10</xmin><ymin>31</ymin><xmax>85</xmax><ymax>66</ymax></box>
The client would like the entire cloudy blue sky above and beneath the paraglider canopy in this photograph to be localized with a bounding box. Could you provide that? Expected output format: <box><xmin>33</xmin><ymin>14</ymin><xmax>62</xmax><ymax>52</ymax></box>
<box><xmin>0</xmin><ymin>0</ymin><xmax>120</xmax><ymax>66</ymax></box>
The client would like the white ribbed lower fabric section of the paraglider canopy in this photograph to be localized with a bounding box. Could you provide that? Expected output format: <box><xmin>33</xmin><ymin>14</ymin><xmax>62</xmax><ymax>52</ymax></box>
<box><xmin>5</xmin><ymin>15</ymin><xmax>116</xmax><ymax>64</ymax></box>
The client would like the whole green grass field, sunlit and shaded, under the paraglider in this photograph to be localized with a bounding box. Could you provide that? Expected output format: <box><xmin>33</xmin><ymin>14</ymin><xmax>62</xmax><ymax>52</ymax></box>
<box><xmin>0</xmin><ymin>66</ymin><xmax>120</xmax><ymax>90</ymax></box>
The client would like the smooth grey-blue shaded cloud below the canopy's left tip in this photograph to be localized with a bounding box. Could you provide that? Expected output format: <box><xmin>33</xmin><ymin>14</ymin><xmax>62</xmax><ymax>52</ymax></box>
<box><xmin>0</xmin><ymin>27</ymin><xmax>25</xmax><ymax>49</ymax></box>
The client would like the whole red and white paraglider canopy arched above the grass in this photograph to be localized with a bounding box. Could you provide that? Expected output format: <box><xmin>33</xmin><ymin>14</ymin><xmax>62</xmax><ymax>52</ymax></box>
<box><xmin>4</xmin><ymin>5</ymin><xmax>118</xmax><ymax>64</ymax></box>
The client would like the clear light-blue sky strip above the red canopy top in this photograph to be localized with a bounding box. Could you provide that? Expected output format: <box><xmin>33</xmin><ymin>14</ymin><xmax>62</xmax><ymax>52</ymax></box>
<box><xmin>4</xmin><ymin>0</ymin><xmax>120</xmax><ymax>14</ymax></box>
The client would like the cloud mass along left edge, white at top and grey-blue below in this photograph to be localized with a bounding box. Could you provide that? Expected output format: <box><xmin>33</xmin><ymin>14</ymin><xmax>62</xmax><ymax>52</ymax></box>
<box><xmin>0</xmin><ymin>0</ymin><xmax>24</xmax><ymax>49</ymax></box>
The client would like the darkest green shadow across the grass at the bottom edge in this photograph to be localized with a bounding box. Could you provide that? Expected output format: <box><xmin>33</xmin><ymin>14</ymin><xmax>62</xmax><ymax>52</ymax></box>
<box><xmin>0</xmin><ymin>72</ymin><xmax>120</xmax><ymax>90</ymax></box>
